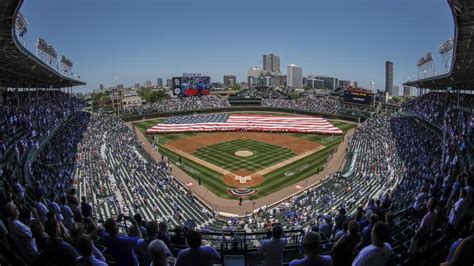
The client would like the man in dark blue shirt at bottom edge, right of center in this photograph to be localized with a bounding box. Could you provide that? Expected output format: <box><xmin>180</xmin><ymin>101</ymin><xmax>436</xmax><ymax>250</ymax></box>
<box><xmin>290</xmin><ymin>231</ymin><xmax>333</xmax><ymax>266</ymax></box>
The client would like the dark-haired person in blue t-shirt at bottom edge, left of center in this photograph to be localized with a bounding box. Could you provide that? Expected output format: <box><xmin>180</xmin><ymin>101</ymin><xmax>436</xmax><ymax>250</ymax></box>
<box><xmin>175</xmin><ymin>230</ymin><xmax>221</xmax><ymax>266</ymax></box>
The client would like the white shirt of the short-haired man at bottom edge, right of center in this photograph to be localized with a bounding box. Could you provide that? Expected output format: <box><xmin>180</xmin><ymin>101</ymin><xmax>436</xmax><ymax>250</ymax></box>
<box><xmin>352</xmin><ymin>243</ymin><xmax>392</xmax><ymax>266</ymax></box>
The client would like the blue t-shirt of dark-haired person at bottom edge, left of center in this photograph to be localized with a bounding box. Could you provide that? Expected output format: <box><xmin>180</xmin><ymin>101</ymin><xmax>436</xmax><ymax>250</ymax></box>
<box><xmin>175</xmin><ymin>246</ymin><xmax>221</xmax><ymax>266</ymax></box>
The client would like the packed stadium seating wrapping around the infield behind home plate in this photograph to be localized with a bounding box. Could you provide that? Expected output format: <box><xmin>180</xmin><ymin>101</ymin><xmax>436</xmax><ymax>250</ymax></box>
<box><xmin>0</xmin><ymin>92</ymin><xmax>474</xmax><ymax>265</ymax></box>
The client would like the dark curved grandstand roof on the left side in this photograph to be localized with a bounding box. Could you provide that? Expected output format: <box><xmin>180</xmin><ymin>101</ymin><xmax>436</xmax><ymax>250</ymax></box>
<box><xmin>0</xmin><ymin>0</ymin><xmax>86</xmax><ymax>88</ymax></box>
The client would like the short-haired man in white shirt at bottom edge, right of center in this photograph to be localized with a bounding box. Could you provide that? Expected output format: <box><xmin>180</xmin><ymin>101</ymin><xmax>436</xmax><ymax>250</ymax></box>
<box><xmin>352</xmin><ymin>222</ymin><xmax>392</xmax><ymax>266</ymax></box>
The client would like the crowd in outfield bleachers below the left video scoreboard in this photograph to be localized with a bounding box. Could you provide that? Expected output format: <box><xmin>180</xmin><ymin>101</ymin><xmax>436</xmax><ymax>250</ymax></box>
<box><xmin>123</xmin><ymin>95</ymin><xmax>230</xmax><ymax>115</ymax></box>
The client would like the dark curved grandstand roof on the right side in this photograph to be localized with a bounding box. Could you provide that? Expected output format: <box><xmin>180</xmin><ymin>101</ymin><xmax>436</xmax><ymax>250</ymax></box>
<box><xmin>404</xmin><ymin>0</ymin><xmax>474</xmax><ymax>90</ymax></box>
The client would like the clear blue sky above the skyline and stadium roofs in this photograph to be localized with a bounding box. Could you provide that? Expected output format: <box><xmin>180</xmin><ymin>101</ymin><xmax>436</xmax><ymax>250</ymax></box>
<box><xmin>21</xmin><ymin>0</ymin><xmax>454</xmax><ymax>90</ymax></box>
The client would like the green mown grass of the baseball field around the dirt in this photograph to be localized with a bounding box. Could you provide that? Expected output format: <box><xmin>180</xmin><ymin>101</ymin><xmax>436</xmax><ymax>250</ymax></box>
<box><xmin>135</xmin><ymin>113</ymin><xmax>355</xmax><ymax>199</ymax></box>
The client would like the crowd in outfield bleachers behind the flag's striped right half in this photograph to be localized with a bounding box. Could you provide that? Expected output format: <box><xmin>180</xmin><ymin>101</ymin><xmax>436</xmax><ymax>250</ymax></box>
<box><xmin>262</xmin><ymin>96</ymin><xmax>340</xmax><ymax>114</ymax></box>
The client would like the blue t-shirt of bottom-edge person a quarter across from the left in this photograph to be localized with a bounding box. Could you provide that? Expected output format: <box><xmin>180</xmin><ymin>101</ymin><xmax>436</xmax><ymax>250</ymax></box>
<box><xmin>102</xmin><ymin>231</ymin><xmax>139</xmax><ymax>266</ymax></box>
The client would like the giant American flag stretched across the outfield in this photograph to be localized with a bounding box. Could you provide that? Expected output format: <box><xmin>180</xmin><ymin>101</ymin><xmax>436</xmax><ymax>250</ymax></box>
<box><xmin>146</xmin><ymin>114</ymin><xmax>342</xmax><ymax>134</ymax></box>
